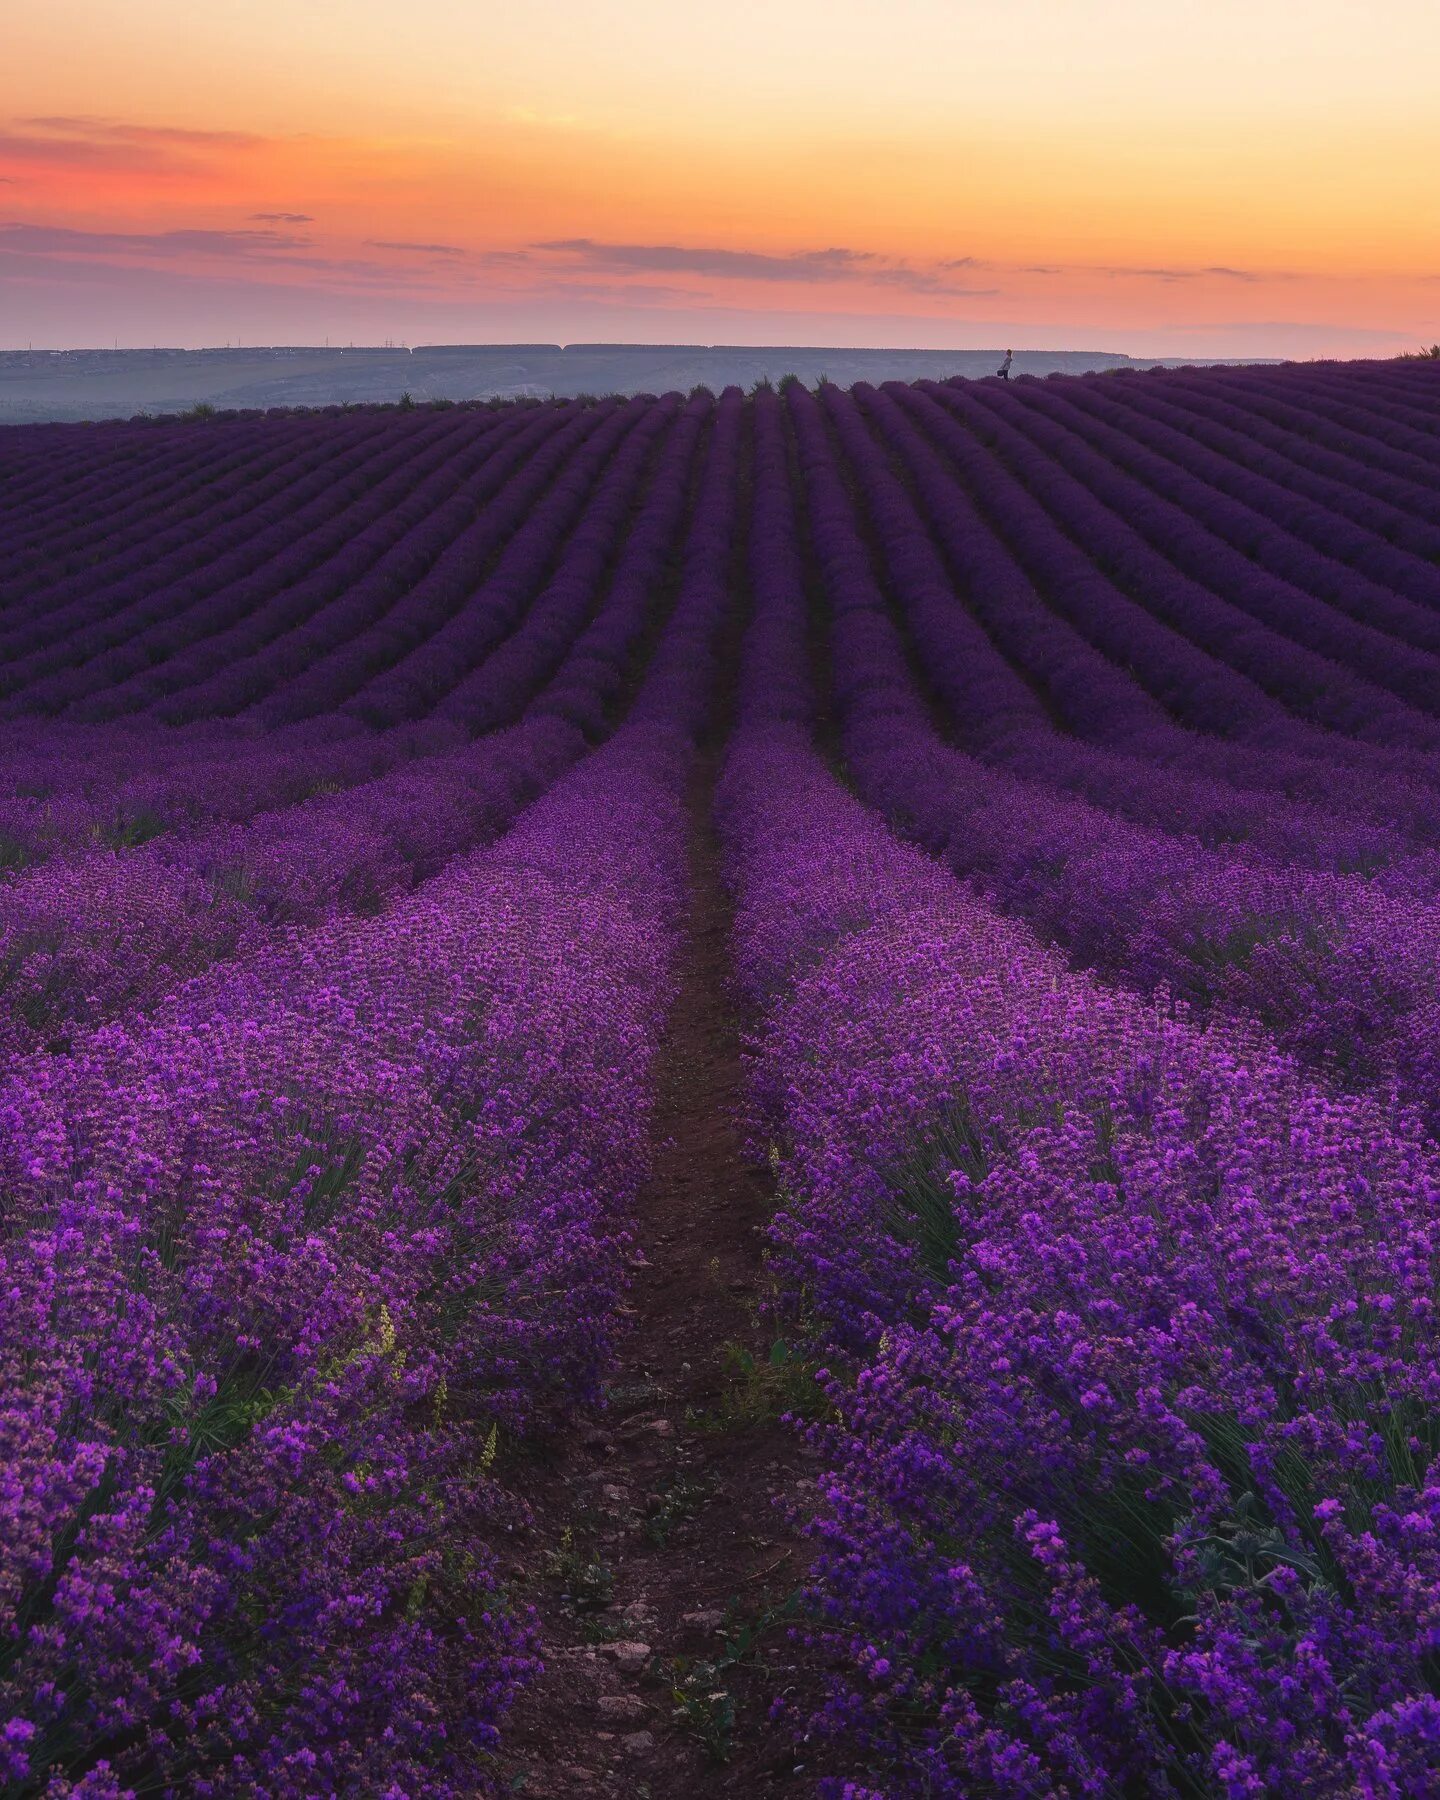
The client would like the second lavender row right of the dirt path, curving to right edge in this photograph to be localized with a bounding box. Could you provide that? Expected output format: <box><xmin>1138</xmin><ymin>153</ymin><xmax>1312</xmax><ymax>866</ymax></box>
<box><xmin>788</xmin><ymin>392</ymin><xmax>1440</xmax><ymax>1127</ymax></box>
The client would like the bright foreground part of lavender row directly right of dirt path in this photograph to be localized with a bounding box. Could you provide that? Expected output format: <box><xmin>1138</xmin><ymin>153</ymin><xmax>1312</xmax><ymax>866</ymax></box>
<box><xmin>722</xmin><ymin>725</ymin><xmax>1440</xmax><ymax>1796</ymax></box>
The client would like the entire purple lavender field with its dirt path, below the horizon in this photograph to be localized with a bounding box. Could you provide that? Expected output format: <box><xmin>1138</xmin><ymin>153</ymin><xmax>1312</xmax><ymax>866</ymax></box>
<box><xmin>0</xmin><ymin>360</ymin><xmax>1440</xmax><ymax>1800</ymax></box>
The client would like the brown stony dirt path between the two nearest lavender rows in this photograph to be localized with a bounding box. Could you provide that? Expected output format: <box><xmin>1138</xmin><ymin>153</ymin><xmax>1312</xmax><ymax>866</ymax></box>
<box><xmin>502</xmin><ymin>767</ymin><xmax>828</xmax><ymax>1800</ymax></box>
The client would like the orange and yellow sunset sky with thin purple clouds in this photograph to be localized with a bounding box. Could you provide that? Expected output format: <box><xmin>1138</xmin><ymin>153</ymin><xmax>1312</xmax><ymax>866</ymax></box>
<box><xmin>0</xmin><ymin>0</ymin><xmax>1440</xmax><ymax>356</ymax></box>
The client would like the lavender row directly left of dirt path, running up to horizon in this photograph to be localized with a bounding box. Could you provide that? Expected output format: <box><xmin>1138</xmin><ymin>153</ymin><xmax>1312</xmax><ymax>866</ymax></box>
<box><xmin>0</xmin><ymin>394</ymin><xmax>742</xmax><ymax>1800</ymax></box>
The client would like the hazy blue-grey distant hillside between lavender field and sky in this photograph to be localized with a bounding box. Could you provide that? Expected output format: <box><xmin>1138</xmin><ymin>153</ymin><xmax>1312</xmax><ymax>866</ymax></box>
<box><xmin>0</xmin><ymin>344</ymin><xmax>1274</xmax><ymax>425</ymax></box>
